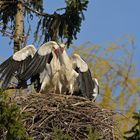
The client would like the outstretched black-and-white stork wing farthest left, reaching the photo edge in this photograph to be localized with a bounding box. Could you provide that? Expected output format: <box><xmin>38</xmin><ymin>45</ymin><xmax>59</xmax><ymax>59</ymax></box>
<box><xmin>0</xmin><ymin>45</ymin><xmax>36</xmax><ymax>89</ymax></box>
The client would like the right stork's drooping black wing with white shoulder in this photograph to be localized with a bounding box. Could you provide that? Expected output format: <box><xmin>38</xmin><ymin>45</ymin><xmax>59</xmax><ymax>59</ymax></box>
<box><xmin>71</xmin><ymin>54</ymin><xmax>95</xmax><ymax>99</ymax></box>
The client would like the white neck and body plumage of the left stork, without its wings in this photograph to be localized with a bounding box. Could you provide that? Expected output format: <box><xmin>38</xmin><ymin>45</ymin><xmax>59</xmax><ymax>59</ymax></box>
<box><xmin>40</xmin><ymin>42</ymin><xmax>61</xmax><ymax>93</ymax></box>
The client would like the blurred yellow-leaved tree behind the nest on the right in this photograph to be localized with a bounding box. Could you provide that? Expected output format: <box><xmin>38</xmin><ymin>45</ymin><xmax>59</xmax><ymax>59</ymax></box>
<box><xmin>74</xmin><ymin>35</ymin><xmax>140</xmax><ymax>136</ymax></box>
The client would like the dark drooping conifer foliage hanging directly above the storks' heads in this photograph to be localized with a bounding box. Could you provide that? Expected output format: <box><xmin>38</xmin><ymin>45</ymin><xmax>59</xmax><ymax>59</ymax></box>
<box><xmin>35</xmin><ymin>0</ymin><xmax>88</xmax><ymax>45</ymax></box>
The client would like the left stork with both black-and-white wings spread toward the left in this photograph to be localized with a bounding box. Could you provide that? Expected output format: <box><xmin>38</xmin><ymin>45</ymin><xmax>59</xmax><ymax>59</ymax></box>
<box><xmin>0</xmin><ymin>41</ymin><xmax>62</xmax><ymax>92</ymax></box>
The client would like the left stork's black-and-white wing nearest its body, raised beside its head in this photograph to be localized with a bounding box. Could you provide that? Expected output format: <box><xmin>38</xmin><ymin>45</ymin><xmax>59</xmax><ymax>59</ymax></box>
<box><xmin>20</xmin><ymin>43</ymin><xmax>53</xmax><ymax>81</ymax></box>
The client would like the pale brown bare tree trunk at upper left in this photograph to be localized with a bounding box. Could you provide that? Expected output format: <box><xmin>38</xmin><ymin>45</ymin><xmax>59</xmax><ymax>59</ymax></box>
<box><xmin>14</xmin><ymin>1</ymin><xmax>24</xmax><ymax>53</ymax></box>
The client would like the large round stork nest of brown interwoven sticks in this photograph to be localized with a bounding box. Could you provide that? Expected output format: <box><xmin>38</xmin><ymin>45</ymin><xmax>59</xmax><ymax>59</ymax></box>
<box><xmin>9</xmin><ymin>93</ymin><xmax>118</xmax><ymax>140</ymax></box>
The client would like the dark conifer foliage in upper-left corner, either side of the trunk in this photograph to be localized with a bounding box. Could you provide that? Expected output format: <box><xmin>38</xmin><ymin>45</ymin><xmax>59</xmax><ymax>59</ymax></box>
<box><xmin>0</xmin><ymin>0</ymin><xmax>43</xmax><ymax>30</ymax></box>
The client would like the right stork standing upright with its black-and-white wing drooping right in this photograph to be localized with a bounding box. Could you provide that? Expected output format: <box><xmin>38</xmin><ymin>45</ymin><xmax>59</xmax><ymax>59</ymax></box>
<box><xmin>59</xmin><ymin>44</ymin><xmax>99</xmax><ymax>100</ymax></box>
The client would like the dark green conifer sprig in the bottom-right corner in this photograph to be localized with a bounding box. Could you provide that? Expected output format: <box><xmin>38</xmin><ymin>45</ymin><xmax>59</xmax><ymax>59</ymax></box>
<box><xmin>124</xmin><ymin>111</ymin><xmax>140</xmax><ymax>140</ymax></box>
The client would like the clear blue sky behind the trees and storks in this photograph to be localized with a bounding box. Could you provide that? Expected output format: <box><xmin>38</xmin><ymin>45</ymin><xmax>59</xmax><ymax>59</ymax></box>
<box><xmin>0</xmin><ymin>0</ymin><xmax>140</xmax><ymax>76</ymax></box>
